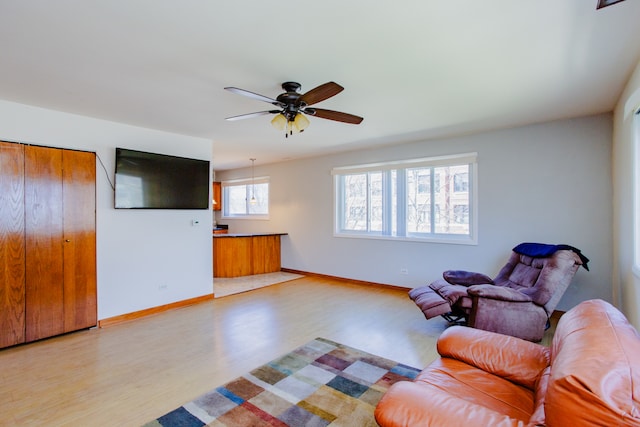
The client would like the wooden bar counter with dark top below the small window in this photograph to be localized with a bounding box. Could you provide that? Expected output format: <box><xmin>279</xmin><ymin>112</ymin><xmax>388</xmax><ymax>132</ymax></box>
<box><xmin>213</xmin><ymin>233</ymin><xmax>287</xmax><ymax>277</ymax></box>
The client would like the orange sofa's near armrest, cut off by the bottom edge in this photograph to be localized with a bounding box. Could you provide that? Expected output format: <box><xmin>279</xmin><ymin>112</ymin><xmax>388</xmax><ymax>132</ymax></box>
<box><xmin>374</xmin><ymin>381</ymin><xmax>524</xmax><ymax>427</ymax></box>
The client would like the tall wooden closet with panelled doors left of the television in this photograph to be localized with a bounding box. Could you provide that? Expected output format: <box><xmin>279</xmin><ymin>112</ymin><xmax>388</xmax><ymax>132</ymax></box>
<box><xmin>0</xmin><ymin>142</ymin><xmax>97</xmax><ymax>347</ymax></box>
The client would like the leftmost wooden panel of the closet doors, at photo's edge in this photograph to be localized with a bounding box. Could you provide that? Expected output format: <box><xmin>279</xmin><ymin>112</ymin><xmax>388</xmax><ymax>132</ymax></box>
<box><xmin>0</xmin><ymin>142</ymin><xmax>25</xmax><ymax>348</ymax></box>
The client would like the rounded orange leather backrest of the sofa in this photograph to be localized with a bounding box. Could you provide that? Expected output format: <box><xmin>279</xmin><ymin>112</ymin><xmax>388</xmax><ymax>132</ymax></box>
<box><xmin>545</xmin><ymin>300</ymin><xmax>640</xmax><ymax>426</ymax></box>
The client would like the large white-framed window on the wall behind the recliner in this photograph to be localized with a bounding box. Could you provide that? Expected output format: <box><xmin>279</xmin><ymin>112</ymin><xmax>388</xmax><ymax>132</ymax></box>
<box><xmin>332</xmin><ymin>153</ymin><xmax>477</xmax><ymax>244</ymax></box>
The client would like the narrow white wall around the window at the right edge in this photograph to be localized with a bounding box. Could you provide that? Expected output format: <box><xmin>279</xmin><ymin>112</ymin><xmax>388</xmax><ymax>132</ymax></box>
<box><xmin>612</xmin><ymin>58</ymin><xmax>640</xmax><ymax>329</ymax></box>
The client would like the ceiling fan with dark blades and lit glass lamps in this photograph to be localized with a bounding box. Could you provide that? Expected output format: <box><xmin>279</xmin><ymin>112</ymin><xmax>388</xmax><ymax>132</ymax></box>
<box><xmin>225</xmin><ymin>82</ymin><xmax>363</xmax><ymax>137</ymax></box>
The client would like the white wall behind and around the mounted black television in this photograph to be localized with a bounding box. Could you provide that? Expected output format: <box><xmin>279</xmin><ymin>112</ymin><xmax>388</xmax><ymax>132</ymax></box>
<box><xmin>0</xmin><ymin>100</ymin><xmax>213</xmax><ymax>319</ymax></box>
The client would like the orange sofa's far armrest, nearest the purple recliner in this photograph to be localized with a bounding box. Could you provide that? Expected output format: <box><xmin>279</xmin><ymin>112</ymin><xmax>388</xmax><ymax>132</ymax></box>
<box><xmin>437</xmin><ymin>326</ymin><xmax>550</xmax><ymax>390</ymax></box>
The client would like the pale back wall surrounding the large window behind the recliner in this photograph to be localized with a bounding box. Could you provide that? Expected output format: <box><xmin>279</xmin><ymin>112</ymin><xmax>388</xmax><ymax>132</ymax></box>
<box><xmin>219</xmin><ymin>114</ymin><xmax>612</xmax><ymax>310</ymax></box>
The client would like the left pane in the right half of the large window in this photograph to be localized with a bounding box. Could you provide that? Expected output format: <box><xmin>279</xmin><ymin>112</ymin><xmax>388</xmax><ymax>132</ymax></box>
<box><xmin>406</xmin><ymin>168</ymin><xmax>431</xmax><ymax>233</ymax></box>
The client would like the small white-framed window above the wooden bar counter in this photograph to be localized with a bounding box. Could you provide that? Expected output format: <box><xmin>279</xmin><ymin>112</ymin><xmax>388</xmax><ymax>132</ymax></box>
<box><xmin>222</xmin><ymin>177</ymin><xmax>269</xmax><ymax>219</ymax></box>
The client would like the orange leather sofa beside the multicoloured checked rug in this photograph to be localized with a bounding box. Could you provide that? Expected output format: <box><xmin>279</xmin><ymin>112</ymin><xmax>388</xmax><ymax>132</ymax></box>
<box><xmin>375</xmin><ymin>300</ymin><xmax>640</xmax><ymax>427</ymax></box>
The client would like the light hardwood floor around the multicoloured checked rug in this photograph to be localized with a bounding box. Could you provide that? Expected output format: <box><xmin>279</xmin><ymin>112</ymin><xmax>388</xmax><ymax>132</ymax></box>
<box><xmin>0</xmin><ymin>277</ymin><xmax>447</xmax><ymax>426</ymax></box>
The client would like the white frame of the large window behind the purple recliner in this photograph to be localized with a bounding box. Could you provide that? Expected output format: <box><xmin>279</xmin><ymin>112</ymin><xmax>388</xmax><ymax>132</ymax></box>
<box><xmin>331</xmin><ymin>153</ymin><xmax>478</xmax><ymax>245</ymax></box>
